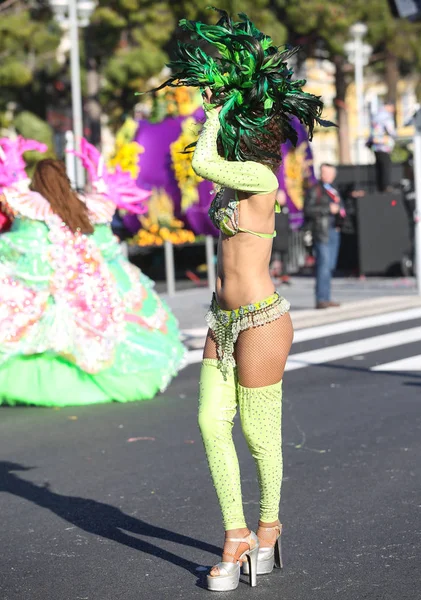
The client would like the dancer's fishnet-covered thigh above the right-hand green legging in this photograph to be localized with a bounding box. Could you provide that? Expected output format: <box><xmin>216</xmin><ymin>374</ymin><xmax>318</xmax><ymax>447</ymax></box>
<box><xmin>233</xmin><ymin>313</ymin><xmax>294</xmax><ymax>388</ymax></box>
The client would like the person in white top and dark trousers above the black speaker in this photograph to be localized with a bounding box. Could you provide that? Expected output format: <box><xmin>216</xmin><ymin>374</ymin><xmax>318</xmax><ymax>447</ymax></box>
<box><xmin>367</xmin><ymin>102</ymin><xmax>396</xmax><ymax>192</ymax></box>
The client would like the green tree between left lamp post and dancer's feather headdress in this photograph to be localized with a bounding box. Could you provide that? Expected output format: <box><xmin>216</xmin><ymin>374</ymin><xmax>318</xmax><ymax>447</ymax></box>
<box><xmin>88</xmin><ymin>0</ymin><xmax>286</xmax><ymax>122</ymax></box>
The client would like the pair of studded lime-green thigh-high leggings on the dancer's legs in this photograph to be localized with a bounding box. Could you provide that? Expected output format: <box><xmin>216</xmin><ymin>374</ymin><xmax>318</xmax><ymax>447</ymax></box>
<box><xmin>199</xmin><ymin>358</ymin><xmax>282</xmax><ymax>530</ymax></box>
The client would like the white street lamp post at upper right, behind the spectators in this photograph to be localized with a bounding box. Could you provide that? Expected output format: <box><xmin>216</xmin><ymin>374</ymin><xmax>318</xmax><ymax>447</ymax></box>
<box><xmin>344</xmin><ymin>23</ymin><xmax>373</xmax><ymax>165</ymax></box>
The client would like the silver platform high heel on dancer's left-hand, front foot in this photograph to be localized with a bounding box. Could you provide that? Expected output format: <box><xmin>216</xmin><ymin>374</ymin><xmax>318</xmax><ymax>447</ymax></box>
<box><xmin>207</xmin><ymin>531</ymin><xmax>259</xmax><ymax>592</ymax></box>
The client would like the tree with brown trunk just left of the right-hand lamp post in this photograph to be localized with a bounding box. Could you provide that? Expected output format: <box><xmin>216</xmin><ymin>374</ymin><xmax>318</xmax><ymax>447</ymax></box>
<box><xmin>273</xmin><ymin>0</ymin><xmax>421</xmax><ymax>163</ymax></box>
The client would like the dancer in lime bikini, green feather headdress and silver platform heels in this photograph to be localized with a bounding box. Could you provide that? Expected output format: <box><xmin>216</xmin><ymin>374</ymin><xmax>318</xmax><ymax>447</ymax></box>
<box><xmin>151</xmin><ymin>11</ymin><xmax>327</xmax><ymax>591</ymax></box>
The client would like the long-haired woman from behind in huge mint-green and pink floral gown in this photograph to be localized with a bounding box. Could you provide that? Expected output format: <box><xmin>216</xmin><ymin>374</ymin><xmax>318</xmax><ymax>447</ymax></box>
<box><xmin>0</xmin><ymin>154</ymin><xmax>185</xmax><ymax>406</ymax></box>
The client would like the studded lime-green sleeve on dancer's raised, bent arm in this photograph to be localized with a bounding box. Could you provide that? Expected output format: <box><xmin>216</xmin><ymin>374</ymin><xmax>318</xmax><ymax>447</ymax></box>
<box><xmin>192</xmin><ymin>110</ymin><xmax>278</xmax><ymax>194</ymax></box>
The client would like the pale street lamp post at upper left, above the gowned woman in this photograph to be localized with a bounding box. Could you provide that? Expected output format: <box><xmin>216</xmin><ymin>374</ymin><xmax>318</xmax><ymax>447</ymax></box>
<box><xmin>50</xmin><ymin>0</ymin><xmax>95</xmax><ymax>188</ymax></box>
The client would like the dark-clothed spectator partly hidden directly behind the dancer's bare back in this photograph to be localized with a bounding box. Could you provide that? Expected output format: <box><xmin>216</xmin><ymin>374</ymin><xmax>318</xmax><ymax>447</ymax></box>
<box><xmin>270</xmin><ymin>190</ymin><xmax>291</xmax><ymax>285</ymax></box>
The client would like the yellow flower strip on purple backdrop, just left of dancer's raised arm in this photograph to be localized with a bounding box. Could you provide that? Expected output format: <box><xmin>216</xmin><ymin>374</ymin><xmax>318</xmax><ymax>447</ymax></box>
<box><xmin>170</xmin><ymin>117</ymin><xmax>203</xmax><ymax>212</ymax></box>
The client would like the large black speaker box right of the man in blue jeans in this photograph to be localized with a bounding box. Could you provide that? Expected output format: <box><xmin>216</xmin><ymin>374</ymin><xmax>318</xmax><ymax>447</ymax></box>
<box><xmin>356</xmin><ymin>192</ymin><xmax>411</xmax><ymax>275</ymax></box>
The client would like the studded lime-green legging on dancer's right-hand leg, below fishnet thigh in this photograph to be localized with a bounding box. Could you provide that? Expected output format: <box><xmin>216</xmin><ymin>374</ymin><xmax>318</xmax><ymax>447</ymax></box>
<box><xmin>238</xmin><ymin>381</ymin><xmax>282</xmax><ymax>523</ymax></box>
